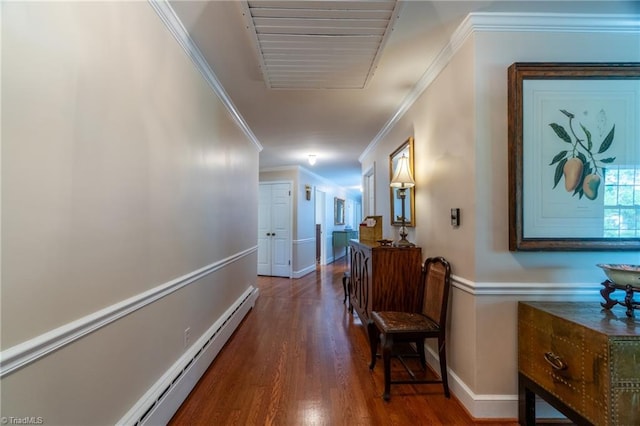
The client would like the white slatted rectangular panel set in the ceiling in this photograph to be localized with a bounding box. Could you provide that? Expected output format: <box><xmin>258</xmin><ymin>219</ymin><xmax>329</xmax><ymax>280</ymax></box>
<box><xmin>243</xmin><ymin>0</ymin><xmax>399</xmax><ymax>89</ymax></box>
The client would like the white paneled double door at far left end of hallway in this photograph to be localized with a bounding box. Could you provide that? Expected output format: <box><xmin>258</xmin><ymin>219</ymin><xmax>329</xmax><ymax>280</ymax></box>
<box><xmin>258</xmin><ymin>183</ymin><xmax>291</xmax><ymax>277</ymax></box>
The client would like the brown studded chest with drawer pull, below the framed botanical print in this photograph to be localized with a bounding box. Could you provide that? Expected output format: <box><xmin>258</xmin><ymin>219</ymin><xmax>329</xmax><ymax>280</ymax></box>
<box><xmin>518</xmin><ymin>302</ymin><xmax>640</xmax><ymax>426</ymax></box>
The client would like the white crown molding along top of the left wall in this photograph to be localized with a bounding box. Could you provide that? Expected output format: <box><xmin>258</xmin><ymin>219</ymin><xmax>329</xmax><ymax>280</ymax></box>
<box><xmin>148</xmin><ymin>0</ymin><xmax>262</xmax><ymax>152</ymax></box>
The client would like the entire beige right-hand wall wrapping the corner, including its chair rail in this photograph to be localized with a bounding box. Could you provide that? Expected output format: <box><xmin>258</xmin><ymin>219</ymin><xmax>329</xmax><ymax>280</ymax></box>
<box><xmin>362</xmin><ymin>16</ymin><xmax>640</xmax><ymax>417</ymax></box>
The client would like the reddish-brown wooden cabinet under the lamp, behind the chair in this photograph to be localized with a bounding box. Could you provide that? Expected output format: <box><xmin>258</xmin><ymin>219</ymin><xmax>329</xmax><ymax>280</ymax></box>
<box><xmin>349</xmin><ymin>240</ymin><xmax>422</xmax><ymax>325</ymax></box>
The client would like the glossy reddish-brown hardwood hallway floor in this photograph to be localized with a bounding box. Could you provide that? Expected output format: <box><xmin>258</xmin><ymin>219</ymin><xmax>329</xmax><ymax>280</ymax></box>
<box><xmin>170</xmin><ymin>261</ymin><xmax>517</xmax><ymax>426</ymax></box>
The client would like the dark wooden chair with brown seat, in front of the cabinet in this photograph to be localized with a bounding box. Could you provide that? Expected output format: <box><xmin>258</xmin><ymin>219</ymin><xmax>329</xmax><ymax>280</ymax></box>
<box><xmin>368</xmin><ymin>257</ymin><xmax>451</xmax><ymax>401</ymax></box>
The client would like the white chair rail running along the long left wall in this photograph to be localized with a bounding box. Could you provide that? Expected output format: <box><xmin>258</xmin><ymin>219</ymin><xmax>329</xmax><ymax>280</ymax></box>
<box><xmin>0</xmin><ymin>246</ymin><xmax>258</xmax><ymax>377</ymax></box>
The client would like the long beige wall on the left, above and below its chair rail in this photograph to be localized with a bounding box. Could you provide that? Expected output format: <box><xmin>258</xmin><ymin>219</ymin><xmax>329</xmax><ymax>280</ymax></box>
<box><xmin>1</xmin><ymin>2</ymin><xmax>258</xmax><ymax>425</ymax></box>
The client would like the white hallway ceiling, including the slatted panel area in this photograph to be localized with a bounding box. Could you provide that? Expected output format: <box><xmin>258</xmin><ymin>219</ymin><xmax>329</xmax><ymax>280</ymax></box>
<box><xmin>170</xmin><ymin>0</ymin><xmax>640</xmax><ymax>192</ymax></box>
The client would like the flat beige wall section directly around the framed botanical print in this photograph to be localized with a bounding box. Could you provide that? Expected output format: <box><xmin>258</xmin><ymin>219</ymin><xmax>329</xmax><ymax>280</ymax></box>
<box><xmin>474</xmin><ymin>28</ymin><xmax>640</xmax><ymax>393</ymax></box>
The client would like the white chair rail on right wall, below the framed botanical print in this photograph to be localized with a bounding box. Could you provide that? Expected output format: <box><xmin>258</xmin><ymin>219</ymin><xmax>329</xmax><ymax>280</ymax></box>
<box><xmin>451</xmin><ymin>275</ymin><xmax>602</xmax><ymax>297</ymax></box>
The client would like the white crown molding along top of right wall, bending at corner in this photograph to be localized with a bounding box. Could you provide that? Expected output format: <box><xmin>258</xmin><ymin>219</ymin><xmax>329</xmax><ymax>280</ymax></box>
<box><xmin>358</xmin><ymin>12</ymin><xmax>640</xmax><ymax>163</ymax></box>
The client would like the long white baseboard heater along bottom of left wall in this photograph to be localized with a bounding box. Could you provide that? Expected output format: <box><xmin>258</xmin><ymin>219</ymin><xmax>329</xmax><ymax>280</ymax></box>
<box><xmin>118</xmin><ymin>287</ymin><xmax>259</xmax><ymax>426</ymax></box>
